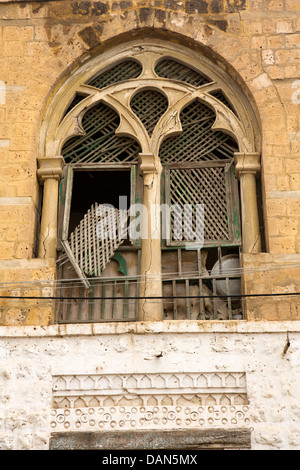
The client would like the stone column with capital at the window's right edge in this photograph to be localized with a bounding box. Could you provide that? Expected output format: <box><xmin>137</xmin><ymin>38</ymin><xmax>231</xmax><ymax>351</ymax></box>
<box><xmin>234</xmin><ymin>153</ymin><xmax>261</xmax><ymax>253</ymax></box>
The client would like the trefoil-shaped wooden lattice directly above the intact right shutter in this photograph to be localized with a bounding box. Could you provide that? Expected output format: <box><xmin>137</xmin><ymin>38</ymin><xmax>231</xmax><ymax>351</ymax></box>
<box><xmin>159</xmin><ymin>100</ymin><xmax>238</xmax><ymax>163</ymax></box>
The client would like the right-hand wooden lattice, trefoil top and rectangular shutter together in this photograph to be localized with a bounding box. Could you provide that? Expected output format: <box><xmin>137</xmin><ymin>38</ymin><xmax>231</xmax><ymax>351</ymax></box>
<box><xmin>159</xmin><ymin>100</ymin><xmax>240</xmax><ymax>245</ymax></box>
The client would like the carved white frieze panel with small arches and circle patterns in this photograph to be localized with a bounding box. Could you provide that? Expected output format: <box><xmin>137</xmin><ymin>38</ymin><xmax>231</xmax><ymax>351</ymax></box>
<box><xmin>50</xmin><ymin>372</ymin><xmax>249</xmax><ymax>432</ymax></box>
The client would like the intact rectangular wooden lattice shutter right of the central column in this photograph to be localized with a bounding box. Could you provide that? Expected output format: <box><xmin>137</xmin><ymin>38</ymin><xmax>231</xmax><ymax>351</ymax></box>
<box><xmin>165</xmin><ymin>162</ymin><xmax>241</xmax><ymax>245</ymax></box>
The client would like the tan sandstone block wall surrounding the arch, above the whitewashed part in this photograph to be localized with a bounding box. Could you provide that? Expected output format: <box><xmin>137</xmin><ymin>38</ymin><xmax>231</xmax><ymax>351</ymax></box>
<box><xmin>0</xmin><ymin>0</ymin><xmax>300</xmax><ymax>324</ymax></box>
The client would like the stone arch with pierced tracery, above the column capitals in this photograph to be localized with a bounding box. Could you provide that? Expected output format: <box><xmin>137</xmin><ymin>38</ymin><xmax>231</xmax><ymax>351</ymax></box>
<box><xmin>39</xmin><ymin>39</ymin><xmax>260</xmax><ymax>158</ymax></box>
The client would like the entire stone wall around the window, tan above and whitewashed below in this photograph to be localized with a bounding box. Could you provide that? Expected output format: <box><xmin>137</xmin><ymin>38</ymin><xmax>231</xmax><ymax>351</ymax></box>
<box><xmin>0</xmin><ymin>0</ymin><xmax>300</xmax><ymax>450</ymax></box>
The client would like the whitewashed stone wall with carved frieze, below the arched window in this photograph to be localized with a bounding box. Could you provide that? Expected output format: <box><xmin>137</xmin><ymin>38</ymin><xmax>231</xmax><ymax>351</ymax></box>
<box><xmin>0</xmin><ymin>321</ymin><xmax>300</xmax><ymax>450</ymax></box>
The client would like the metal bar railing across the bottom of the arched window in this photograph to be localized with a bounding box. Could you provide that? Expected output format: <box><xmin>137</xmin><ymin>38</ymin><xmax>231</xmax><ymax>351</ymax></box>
<box><xmin>57</xmin><ymin>249</ymin><xmax>243</xmax><ymax>323</ymax></box>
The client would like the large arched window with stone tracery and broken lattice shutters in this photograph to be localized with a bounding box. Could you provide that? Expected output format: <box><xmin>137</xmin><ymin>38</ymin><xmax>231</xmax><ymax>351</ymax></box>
<box><xmin>40</xmin><ymin>41</ymin><xmax>259</xmax><ymax>322</ymax></box>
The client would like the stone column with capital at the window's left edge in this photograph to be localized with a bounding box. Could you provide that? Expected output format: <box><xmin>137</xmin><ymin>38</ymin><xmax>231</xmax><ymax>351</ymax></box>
<box><xmin>37</xmin><ymin>157</ymin><xmax>64</xmax><ymax>258</ymax></box>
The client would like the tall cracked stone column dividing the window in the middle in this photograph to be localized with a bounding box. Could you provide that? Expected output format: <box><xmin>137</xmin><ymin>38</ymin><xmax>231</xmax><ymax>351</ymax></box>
<box><xmin>139</xmin><ymin>153</ymin><xmax>163</xmax><ymax>321</ymax></box>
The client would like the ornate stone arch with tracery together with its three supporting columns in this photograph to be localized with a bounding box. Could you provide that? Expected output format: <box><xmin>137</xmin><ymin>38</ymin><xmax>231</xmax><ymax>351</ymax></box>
<box><xmin>38</xmin><ymin>39</ymin><xmax>260</xmax><ymax>320</ymax></box>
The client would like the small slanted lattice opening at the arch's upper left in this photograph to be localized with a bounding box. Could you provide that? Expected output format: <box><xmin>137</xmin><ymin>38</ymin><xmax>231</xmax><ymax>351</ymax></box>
<box><xmin>87</xmin><ymin>60</ymin><xmax>142</xmax><ymax>89</ymax></box>
